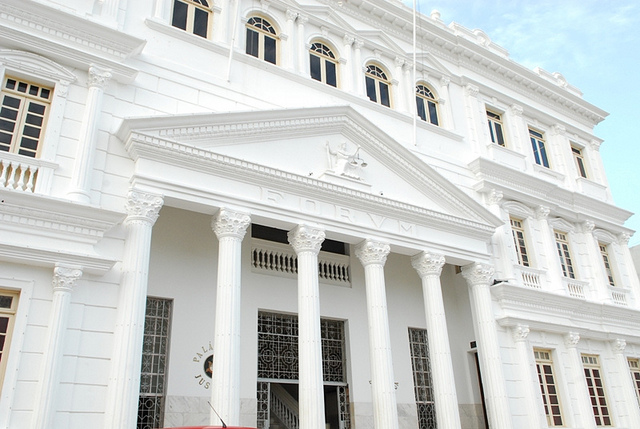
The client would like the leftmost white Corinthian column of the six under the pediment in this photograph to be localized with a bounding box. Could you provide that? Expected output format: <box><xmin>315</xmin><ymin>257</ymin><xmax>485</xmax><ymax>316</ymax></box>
<box><xmin>104</xmin><ymin>190</ymin><xmax>163</xmax><ymax>429</ymax></box>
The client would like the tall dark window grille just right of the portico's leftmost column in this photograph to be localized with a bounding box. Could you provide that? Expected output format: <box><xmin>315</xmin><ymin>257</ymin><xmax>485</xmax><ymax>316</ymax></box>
<box><xmin>137</xmin><ymin>297</ymin><xmax>173</xmax><ymax>429</ymax></box>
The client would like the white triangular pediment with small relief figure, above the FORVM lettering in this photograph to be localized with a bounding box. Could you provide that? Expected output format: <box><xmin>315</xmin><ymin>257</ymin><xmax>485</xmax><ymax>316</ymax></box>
<box><xmin>119</xmin><ymin>106</ymin><xmax>501</xmax><ymax>249</ymax></box>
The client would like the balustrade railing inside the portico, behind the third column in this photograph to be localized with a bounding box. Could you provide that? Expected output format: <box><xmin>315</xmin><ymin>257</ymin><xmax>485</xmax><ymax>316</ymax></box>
<box><xmin>251</xmin><ymin>239</ymin><xmax>351</xmax><ymax>286</ymax></box>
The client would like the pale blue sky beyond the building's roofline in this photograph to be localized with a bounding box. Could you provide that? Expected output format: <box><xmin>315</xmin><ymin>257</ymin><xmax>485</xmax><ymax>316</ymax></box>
<box><xmin>404</xmin><ymin>0</ymin><xmax>640</xmax><ymax>246</ymax></box>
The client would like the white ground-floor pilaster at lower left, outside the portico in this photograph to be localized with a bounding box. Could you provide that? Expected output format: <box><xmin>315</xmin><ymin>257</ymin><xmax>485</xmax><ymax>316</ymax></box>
<box><xmin>33</xmin><ymin>264</ymin><xmax>82</xmax><ymax>429</ymax></box>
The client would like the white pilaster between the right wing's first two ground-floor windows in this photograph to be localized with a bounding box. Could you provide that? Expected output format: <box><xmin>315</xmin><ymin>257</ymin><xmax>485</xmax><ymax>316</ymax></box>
<box><xmin>564</xmin><ymin>332</ymin><xmax>596</xmax><ymax>429</ymax></box>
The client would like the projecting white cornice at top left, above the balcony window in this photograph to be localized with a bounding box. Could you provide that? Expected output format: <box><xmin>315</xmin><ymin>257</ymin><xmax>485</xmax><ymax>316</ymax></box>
<box><xmin>0</xmin><ymin>0</ymin><xmax>146</xmax><ymax>82</ymax></box>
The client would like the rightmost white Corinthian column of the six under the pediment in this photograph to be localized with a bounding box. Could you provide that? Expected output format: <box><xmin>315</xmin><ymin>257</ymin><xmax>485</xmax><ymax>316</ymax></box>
<box><xmin>462</xmin><ymin>264</ymin><xmax>512</xmax><ymax>429</ymax></box>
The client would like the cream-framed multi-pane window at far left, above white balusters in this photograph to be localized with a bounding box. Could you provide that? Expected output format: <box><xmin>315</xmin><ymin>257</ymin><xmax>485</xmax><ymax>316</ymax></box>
<box><xmin>0</xmin><ymin>77</ymin><xmax>53</xmax><ymax>158</ymax></box>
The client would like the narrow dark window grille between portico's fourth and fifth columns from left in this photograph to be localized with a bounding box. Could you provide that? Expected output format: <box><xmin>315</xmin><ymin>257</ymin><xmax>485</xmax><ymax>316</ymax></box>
<box><xmin>409</xmin><ymin>328</ymin><xmax>438</xmax><ymax>429</ymax></box>
